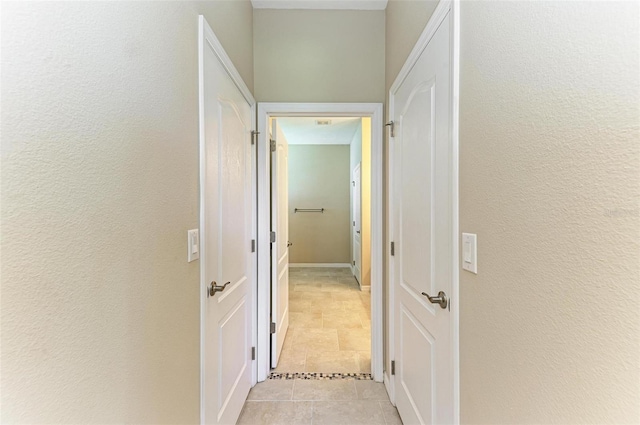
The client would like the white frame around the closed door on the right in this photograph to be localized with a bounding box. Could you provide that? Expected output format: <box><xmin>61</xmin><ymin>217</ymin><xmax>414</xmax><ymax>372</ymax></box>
<box><xmin>384</xmin><ymin>0</ymin><xmax>460</xmax><ymax>418</ymax></box>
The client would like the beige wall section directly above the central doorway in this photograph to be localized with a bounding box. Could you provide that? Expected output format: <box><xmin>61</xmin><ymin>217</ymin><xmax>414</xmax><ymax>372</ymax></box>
<box><xmin>253</xmin><ymin>9</ymin><xmax>385</xmax><ymax>102</ymax></box>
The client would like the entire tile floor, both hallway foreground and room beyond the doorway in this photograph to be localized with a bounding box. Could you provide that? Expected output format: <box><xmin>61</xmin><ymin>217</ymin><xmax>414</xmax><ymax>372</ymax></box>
<box><xmin>238</xmin><ymin>268</ymin><xmax>402</xmax><ymax>425</ymax></box>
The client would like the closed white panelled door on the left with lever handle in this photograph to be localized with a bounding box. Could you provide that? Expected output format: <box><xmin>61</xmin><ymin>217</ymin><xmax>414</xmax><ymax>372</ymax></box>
<box><xmin>200</xmin><ymin>17</ymin><xmax>255</xmax><ymax>424</ymax></box>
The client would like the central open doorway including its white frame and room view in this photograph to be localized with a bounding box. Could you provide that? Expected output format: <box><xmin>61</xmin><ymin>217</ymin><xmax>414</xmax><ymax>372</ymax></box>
<box><xmin>256</xmin><ymin>103</ymin><xmax>382</xmax><ymax>381</ymax></box>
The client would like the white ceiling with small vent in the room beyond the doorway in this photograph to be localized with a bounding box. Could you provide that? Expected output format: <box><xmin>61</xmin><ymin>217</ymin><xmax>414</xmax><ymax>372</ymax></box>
<box><xmin>277</xmin><ymin>117</ymin><xmax>361</xmax><ymax>145</ymax></box>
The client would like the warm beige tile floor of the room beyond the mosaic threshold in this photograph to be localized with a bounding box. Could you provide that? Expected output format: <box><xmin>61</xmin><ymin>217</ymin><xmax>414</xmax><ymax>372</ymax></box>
<box><xmin>274</xmin><ymin>267</ymin><xmax>371</xmax><ymax>373</ymax></box>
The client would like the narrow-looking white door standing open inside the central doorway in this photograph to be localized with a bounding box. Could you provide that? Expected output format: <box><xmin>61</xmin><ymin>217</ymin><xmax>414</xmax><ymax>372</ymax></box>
<box><xmin>271</xmin><ymin>119</ymin><xmax>289</xmax><ymax>367</ymax></box>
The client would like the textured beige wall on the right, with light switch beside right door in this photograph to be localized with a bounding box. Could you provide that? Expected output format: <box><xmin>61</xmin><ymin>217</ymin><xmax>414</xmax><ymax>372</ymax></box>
<box><xmin>387</xmin><ymin>1</ymin><xmax>640</xmax><ymax>424</ymax></box>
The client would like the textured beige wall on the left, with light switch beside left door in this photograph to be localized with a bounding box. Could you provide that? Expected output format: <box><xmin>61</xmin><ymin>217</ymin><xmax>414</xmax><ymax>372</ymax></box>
<box><xmin>0</xmin><ymin>1</ymin><xmax>253</xmax><ymax>424</ymax></box>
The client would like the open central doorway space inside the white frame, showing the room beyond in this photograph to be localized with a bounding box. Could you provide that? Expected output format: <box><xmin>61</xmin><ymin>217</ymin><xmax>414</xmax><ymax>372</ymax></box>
<box><xmin>268</xmin><ymin>116</ymin><xmax>371</xmax><ymax>377</ymax></box>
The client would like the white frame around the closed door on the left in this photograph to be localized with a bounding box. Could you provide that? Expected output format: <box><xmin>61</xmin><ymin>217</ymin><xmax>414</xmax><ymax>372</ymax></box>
<box><xmin>198</xmin><ymin>15</ymin><xmax>258</xmax><ymax>423</ymax></box>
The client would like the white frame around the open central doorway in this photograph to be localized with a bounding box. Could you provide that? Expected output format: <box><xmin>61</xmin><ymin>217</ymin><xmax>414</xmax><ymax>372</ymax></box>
<box><xmin>257</xmin><ymin>103</ymin><xmax>383</xmax><ymax>382</ymax></box>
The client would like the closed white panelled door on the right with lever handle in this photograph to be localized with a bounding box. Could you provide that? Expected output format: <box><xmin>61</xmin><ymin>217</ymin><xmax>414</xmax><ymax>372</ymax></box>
<box><xmin>392</xmin><ymin>7</ymin><xmax>457</xmax><ymax>424</ymax></box>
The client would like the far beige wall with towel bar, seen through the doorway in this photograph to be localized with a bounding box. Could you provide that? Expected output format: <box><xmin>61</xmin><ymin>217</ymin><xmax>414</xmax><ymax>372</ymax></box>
<box><xmin>289</xmin><ymin>145</ymin><xmax>351</xmax><ymax>263</ymax></box>
